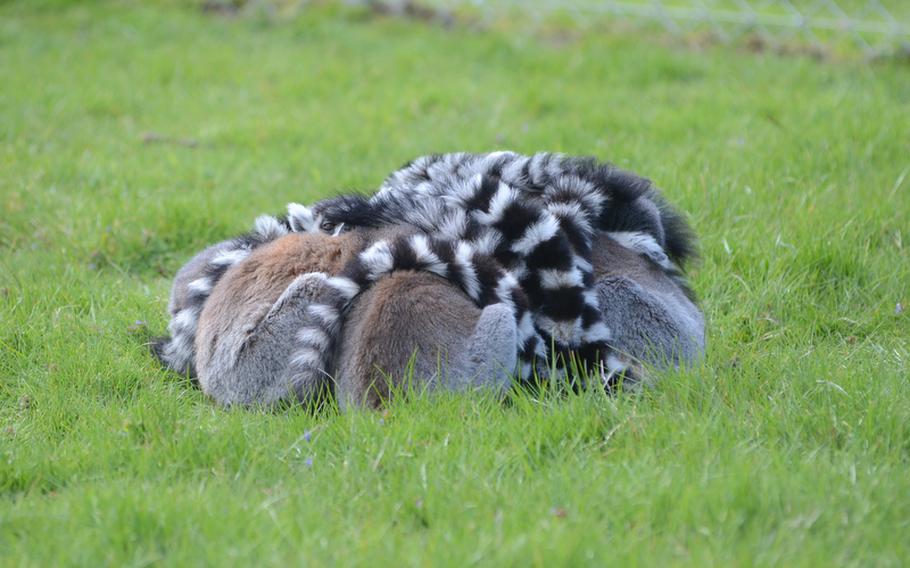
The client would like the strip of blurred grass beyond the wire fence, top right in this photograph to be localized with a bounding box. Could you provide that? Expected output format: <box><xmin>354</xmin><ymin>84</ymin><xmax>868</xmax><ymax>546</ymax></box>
<box><xmin>420</xmin><ymin>0</ymin><xmax>910</xmax><ymax>60</ymax></box>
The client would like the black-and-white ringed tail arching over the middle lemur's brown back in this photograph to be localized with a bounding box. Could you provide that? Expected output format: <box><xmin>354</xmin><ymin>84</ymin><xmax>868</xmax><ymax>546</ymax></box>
<box><xmin>289</xmin><ymin>234</ymin><xmax>545</xmax><ymax>388</ymax></box>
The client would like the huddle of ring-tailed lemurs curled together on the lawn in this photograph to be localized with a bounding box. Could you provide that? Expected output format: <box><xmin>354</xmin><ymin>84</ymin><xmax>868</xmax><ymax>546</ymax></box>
<box><xmin>153</xmin><ymin>152</ymin><xmax>704</xmax><ymax>407</ymax></box>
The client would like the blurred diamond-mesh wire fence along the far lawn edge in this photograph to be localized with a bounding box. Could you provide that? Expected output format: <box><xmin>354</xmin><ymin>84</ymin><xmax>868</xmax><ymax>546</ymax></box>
<box><xmin>355</xmin><ymin>0</ymin><xmax>910</xmax><ymax>56</ymax></box>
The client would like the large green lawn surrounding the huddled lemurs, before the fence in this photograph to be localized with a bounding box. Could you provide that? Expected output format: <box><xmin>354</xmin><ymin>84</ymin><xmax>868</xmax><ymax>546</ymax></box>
<box><xmin>0</xmin><ymin>1</ymin><xmax>910</xmax><ymax>566</ymax></box>
